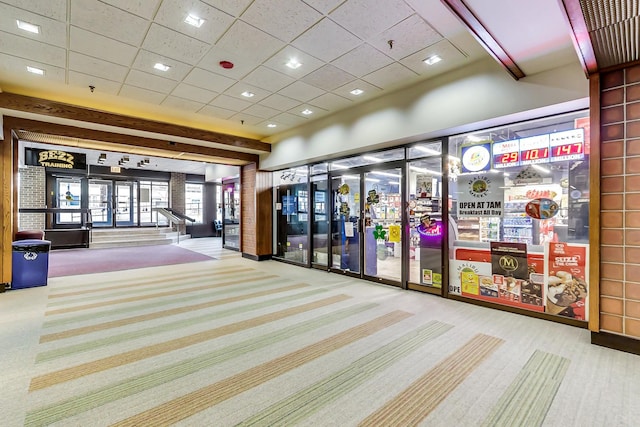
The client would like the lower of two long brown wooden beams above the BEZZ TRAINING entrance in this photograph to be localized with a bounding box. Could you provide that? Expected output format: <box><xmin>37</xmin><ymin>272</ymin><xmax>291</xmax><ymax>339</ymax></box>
<box><xmin>4</xmin><ymin>116</ymin><xmax>259</xmax><ymax>163</ymax></box>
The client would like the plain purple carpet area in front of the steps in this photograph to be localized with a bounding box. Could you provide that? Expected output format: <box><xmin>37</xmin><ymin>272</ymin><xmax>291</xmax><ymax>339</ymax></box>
<box><xmin>49</xmin><ymin>245</ymin><xmax>211</xmax><ymax>277</ymax></box>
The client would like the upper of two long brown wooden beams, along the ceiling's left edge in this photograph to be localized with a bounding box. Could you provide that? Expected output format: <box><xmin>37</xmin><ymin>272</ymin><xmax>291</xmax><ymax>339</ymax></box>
<box><xmin>0</xmin><ymin>92</ymin><xmax>271</xmax><ymax>153</ymax></box>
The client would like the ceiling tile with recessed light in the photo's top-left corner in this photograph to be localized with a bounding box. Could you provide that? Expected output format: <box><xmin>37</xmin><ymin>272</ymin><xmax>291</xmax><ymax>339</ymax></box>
<box><xmin>0</xmin><ymin>3</ymin><xmax>67</xmax><ymax>47</ymax></box>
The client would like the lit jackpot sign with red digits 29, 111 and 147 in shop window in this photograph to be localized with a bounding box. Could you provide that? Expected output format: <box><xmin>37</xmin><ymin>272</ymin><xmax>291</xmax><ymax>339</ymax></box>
<box><xmin>492</xmin><ymin>128</ymin><xmax>584</xmax><ymax>169</ymax></box>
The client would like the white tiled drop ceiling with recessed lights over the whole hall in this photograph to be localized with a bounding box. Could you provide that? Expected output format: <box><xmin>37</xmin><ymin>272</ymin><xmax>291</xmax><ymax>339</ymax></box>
<box><xmin>0</xmin><ymin>0</ymin><xmax>637</xmax><ymax>174</ymax></box>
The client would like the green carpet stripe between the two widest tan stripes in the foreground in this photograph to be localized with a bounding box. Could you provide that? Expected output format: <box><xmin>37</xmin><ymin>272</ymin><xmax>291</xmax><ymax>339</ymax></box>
<box><xmin>239</xmin><ymin>321</ymin><xmax>453</xmax><ymax>426</ymax></box>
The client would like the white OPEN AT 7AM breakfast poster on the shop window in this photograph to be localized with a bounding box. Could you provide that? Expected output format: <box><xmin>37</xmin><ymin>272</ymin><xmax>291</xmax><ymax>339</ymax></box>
<box><xmin>458</xmin><ymin>174</ymin><xmax>504</xmax><ymax>216</ymax></box>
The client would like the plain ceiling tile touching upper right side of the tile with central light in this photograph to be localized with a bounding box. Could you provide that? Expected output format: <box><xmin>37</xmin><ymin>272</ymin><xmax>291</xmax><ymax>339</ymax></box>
<box><xmin>292</xmin><ymin>18</ymin><xmax>362</xmax><ymax>62</ymax></box>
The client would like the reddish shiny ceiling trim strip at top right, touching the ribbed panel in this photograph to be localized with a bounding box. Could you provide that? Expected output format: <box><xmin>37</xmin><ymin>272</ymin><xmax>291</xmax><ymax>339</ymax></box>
<box><xmin>558</xmin><ymin>0</ymin><xmax>598</xmax><ymax>78</ymax></box>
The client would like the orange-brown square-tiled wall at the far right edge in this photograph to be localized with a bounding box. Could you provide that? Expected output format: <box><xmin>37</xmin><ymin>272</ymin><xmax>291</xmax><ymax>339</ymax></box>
<box><xmin>599</xmin><ymin>65</ymin><xmax>640</xmax><ymax>338</ymax></box>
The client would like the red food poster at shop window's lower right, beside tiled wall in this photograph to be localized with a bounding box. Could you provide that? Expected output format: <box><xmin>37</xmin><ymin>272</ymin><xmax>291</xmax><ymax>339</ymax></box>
<box><xmin>545</xmin><ymin>243</ymin><xmax>589</xmax><ymax>320</ymax></box>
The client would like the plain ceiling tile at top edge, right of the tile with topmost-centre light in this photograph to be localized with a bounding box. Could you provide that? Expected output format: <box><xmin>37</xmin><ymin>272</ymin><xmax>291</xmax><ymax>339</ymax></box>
<box><xmin>241</xmin><ymin>0</ymin><xmax>322</xmax><ymax>42</ymax></box>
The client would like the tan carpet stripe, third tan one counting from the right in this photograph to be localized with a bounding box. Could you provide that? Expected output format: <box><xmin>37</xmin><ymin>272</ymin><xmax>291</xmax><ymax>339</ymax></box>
<box><xmin>29</xmin><ymin>295</ymin><xmax>351</xmax><ymax>391</ymax></box>
